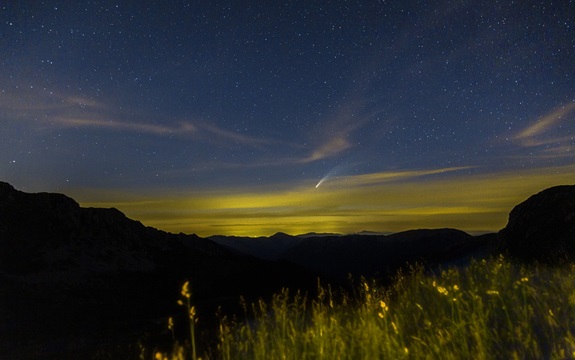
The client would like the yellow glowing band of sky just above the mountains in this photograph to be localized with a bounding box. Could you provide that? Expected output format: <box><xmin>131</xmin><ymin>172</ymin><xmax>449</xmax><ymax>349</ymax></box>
<box><xmin>79</xmin><ymin>166</ymin><xmax>575</xmax><ymax>236</ymax></box>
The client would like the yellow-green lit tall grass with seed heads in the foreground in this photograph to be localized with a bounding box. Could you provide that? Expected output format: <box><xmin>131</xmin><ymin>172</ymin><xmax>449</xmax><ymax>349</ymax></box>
<box><xmin>156</xmin><ymin>257</ymin><xmax>575</xmax><ymax>359</ymax></box>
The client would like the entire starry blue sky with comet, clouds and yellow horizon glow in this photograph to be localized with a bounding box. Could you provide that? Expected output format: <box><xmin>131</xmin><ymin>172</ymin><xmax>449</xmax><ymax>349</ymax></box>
<box><xmin>0</xmin><ymin>0</ymin><xmax>575</xmax><ymax>236</ymax></box>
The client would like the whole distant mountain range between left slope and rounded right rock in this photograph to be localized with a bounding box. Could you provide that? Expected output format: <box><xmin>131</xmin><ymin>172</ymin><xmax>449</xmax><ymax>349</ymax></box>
<box><xmin>209</xmin><ymin>229</ymin><xmax>496</xmax><ymax>281</ymax></box>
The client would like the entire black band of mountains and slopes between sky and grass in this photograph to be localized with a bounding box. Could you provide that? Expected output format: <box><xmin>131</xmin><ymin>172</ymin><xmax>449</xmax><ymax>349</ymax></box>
<box><xmin>0</xmin><ymin>182</ymin><xmax>575</xmax><ymax>359</ymax></box>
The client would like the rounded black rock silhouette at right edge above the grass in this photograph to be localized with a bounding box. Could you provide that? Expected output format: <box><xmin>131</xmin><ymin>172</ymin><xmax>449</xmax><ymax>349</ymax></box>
<box><xmin>499</xmin><ymin>185</ymin><xmax>575</xmax><ymax>263</ymax></box>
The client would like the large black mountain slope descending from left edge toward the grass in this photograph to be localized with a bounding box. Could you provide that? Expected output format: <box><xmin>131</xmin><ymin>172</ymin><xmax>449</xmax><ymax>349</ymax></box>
<box><xmin>0</xmin><ymin>182</ymin><xmax>316</xmax><ymax>359</ymax></box>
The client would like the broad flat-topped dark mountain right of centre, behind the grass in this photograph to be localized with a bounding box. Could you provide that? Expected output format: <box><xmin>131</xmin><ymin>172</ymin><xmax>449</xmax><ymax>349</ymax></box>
<box><xmin>282</xmin><ymin>229</ymin><xmax>487</xmax><ymax>280</ymax></box>
